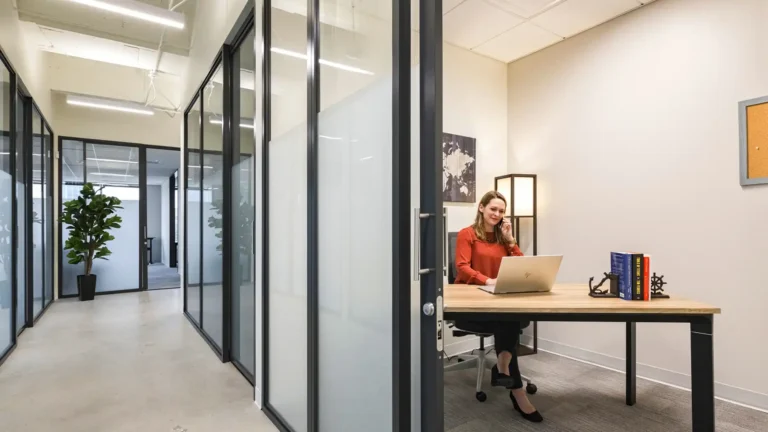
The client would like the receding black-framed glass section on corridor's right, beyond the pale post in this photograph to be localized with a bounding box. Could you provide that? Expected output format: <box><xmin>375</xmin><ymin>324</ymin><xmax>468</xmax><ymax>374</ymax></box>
<box><xmin>180</xmin><ymin>9</ymin><xmax>257</xmax><ymax>383</ymax></box>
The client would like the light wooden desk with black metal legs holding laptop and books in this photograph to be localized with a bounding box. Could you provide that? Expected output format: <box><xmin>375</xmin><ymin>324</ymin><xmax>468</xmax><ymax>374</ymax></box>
<box><xmin>443</xmin><ymin>284</ymin><xmax>720</xmax><ymax>432</ymax></box>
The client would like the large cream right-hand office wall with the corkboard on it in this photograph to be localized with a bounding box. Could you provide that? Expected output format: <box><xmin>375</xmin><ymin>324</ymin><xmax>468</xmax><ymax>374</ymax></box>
<box><xmin>508</xmin><ymin>0</ymin><xmax>768</xmax><ymax>408</ymax></box>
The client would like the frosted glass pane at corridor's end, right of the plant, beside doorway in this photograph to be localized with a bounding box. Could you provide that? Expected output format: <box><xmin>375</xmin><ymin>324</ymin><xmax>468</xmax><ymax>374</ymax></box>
<box><xmin>86</xmin><ymin>143</ymin><xmax>140</xmax><ymax>292</ymax></box>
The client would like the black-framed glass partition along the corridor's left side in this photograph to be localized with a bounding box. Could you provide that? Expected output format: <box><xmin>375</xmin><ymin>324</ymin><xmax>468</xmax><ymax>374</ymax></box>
<box><xmin>0</xmin><ymin>50</ymin><xmax>54</xmax><ymax>364</ymax></box>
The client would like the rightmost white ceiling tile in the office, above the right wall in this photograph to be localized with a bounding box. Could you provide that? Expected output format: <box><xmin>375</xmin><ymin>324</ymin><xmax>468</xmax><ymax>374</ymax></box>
<box><xmin>532</xmin><ymin>0</ymin><xmax>640</xmax><ymax>37</ymax></box>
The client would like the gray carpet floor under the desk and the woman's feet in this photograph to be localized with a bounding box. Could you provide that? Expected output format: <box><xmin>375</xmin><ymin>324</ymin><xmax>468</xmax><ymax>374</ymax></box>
<box><xmin>445</xmin><ymin>351</ymin><xmax>768</xmax><ymax>432</ymax></box>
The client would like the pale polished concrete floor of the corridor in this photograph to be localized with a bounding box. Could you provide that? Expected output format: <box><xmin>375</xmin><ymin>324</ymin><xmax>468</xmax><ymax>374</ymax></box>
<box><xmin>0</xmin><ymin>290</ymin><xmax>276</xmax><ymax>432</ymax></box>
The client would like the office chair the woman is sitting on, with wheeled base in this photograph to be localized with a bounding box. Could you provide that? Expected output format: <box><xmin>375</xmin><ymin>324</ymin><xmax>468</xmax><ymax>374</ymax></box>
<box><xmin>443</xmin><ymin>232</ymin><xmax>538</xmax><ymax>402</ymax></box>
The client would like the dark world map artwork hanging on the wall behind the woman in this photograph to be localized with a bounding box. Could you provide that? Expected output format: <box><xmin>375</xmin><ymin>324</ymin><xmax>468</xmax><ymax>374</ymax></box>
<box><xmin>443</xmin><ymin>133</ymin><xmax>477</xmax><ymax>203</ymax></box>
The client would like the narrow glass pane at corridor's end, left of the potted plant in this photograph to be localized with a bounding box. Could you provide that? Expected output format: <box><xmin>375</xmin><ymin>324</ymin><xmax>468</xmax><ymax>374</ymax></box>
<box><xmin>59</xmin><ymin>140</ymin><xmax>85</xmax><ymax>296</ymax></box>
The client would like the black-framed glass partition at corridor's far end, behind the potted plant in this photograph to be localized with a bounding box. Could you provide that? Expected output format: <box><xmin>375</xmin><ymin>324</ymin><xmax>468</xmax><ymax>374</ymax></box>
<box><xmin>58</xmin><ymin>137</ymin><xmax>180</xmax><ymax>298</ymax></box>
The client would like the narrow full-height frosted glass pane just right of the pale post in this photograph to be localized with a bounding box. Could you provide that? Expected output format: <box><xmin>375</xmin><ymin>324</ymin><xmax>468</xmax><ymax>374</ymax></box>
<box><xmin>265</xmin><ymin>0</ymin><xmax>308</xmax><ymax>432</ymax></box>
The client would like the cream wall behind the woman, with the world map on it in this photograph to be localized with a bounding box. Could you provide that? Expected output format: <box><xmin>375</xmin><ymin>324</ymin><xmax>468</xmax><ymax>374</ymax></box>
<box><xmin>440</xmin><ymin>43</ymin><xmax>508</xmax><ymax>355</ymax></box>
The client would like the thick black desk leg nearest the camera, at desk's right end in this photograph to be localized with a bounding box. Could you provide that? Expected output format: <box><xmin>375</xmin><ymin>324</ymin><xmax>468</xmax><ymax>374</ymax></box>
<box><xmin>691</xmin><ymin>315</ymin><xmax>715</xmax><ymax>432</ymax></box>
